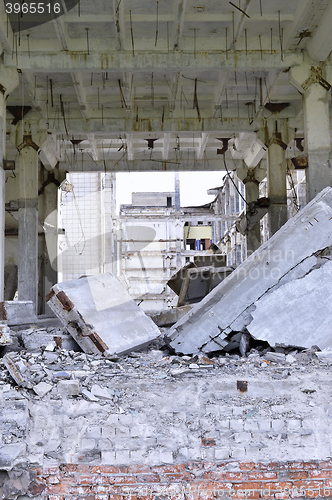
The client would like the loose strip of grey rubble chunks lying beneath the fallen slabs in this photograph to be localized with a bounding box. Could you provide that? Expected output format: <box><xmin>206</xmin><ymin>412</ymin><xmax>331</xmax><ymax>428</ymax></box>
<box><xmin>0</xmin><ymin>329</ymin><xmax>332</xmax><ymax>404</ymax></box>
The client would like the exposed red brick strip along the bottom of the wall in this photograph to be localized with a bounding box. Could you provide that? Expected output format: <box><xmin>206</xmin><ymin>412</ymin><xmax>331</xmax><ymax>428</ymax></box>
<box><xmin>30</xmin><ymin>460</ymin><xmax>332</xmax><ymax>500</ymax></box>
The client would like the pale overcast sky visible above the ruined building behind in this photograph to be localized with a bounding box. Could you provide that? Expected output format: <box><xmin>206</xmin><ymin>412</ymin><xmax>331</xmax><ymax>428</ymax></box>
<box><xmin>116</xmin><ymin>171</ymin><xmax>225</xmax><ymax>212</ymax></box>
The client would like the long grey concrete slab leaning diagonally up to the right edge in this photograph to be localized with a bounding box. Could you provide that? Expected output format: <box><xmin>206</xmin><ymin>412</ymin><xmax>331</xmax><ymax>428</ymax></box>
<box><xmin>168</xmin><ymin>188</ymin><xmax>332</xmax><ymax>353</ymax></box>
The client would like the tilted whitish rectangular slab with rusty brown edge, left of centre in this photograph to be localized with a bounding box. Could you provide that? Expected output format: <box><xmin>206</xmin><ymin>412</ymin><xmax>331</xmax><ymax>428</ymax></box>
<box><xmin>46</xmin><ymin>273</ymin><xmax>160</xmax><ymax>356</ymax></box>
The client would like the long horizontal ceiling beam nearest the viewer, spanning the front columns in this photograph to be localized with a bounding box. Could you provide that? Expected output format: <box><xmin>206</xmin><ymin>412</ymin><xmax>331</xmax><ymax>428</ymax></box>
<box><xmin>4</xmin><ymin>50</ymin><xmax>303</xmax><ymax>75</ymax></box>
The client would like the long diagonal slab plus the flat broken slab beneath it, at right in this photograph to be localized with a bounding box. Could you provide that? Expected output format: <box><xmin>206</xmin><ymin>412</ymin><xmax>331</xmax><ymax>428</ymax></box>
<box><xmin>167</xmin><ymin>188</ymin><xmax>332</xmax><ymax>354</ymax></box>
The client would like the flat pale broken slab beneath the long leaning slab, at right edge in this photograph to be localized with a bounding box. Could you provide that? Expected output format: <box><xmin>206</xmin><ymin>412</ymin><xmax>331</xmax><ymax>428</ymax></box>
<box><xmin>247</xmin><ymin>260</ymin><xmax>332</xmax><ymax>349</ymax></box>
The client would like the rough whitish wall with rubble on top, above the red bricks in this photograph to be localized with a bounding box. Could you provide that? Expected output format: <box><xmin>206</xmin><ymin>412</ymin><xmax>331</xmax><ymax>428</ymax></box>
<box><xmin>0</xmin><ymin>349</ymin><xmax>332</xmax><ymax>470</ymax></box>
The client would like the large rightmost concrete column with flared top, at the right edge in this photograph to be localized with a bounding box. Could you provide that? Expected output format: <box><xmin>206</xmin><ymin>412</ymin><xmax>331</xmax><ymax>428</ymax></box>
<box><xmin>290</xmin><ymin>64</ymin><xmax>332</xmax><ymax>203</ymax></box>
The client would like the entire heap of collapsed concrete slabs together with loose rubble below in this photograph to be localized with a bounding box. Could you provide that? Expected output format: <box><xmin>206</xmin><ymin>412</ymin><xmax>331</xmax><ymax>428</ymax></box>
<box><xmin>0</xmin><ymin>188</ymin><xmax>332</xmax><ymax>390</ymax></box>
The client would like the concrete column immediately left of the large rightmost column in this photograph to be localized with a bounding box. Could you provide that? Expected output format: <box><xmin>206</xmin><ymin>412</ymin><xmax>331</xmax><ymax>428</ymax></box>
<box><xmin>265</xmin><ymin>120</ymin><xmax>288</xmax><ymax>237</ymax></box>
